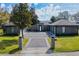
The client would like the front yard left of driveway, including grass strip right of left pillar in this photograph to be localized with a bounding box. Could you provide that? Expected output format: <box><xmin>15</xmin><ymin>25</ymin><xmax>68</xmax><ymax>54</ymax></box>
<box><xmin>0</xmin><ymin>29</ymin><xmax>28</xmax><ymax>54</ymax></box>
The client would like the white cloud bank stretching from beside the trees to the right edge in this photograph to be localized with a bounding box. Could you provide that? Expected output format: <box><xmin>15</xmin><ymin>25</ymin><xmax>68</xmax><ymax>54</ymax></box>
<box><xmin>36</xmin><ymin>4</ymin><xmax>79</xmax><ymax>21</ymax></box>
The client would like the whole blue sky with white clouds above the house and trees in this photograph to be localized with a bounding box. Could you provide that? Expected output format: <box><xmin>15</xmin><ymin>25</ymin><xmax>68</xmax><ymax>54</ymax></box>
<box><xmin>0</xmin><ymin>3</ymin><xmax>79</xmax><ymax>21</ymax></box>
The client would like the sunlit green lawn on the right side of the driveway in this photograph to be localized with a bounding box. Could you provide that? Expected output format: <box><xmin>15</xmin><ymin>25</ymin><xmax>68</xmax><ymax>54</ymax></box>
<box><xmin>48</xmin><ymin>36</ymin><xmax>79</xmax><ymax>52</ymax></box>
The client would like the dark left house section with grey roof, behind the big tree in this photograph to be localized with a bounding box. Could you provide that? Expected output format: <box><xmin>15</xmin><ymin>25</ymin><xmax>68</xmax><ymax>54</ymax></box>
<box><xmin>2</xmin><ymin>22</ymin><xmax>20</xmax><ymax>35</ymax></box>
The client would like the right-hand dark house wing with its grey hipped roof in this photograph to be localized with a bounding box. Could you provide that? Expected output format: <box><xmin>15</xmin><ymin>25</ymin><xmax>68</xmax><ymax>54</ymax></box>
<box><xmin>49</xmin><ymin>20</ymin><xmax>79</xmax><ymax>35</ymax></box>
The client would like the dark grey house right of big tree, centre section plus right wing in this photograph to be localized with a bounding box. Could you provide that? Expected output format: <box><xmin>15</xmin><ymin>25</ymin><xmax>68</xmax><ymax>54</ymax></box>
<box><xmin>28</xmin><ymin>19</ymin><xmax>79</xmax><ymax>35</ymax></box>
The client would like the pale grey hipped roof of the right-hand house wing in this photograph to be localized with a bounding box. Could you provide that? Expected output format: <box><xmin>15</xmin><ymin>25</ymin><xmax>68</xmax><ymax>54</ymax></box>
<box><xmin>49</xmin><ymin>19</ymin><xmax>79</xmax><ymax>26</ymax></box>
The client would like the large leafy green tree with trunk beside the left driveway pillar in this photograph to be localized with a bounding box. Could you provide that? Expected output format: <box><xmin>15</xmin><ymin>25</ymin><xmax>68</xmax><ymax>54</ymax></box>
<box><xmin>10</xmin><ymin>3</ymin><xmax>32</xmax><ymax>38</ymax></box>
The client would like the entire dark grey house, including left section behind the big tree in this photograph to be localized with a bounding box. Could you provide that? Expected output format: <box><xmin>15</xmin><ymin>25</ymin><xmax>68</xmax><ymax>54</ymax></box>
<box><xmin>3</xmin><ymin>19</ymin><xmax>79</xmax><ymax>35</ymax></box>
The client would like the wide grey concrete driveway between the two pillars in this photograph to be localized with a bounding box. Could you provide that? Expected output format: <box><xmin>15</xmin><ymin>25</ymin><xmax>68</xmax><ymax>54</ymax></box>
<box><xmin>20</xmin><ymin>32</ymin><xmax>50</xmax><ymax>55</ymax></box>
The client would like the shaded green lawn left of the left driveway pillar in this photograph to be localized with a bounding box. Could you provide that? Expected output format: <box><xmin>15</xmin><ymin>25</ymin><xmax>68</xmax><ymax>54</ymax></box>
<box><xmin>0</xmin><ymin>36</ymin><xmax>18</xmax><ymax>54</ymax></box>
